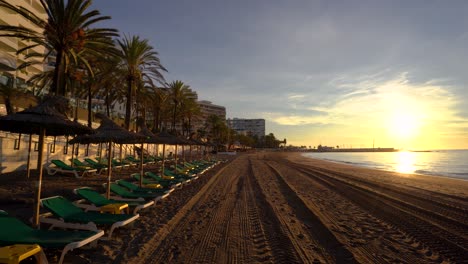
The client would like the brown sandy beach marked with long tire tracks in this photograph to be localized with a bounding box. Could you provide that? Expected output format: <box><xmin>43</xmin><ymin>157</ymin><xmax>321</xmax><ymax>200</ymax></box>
<box><xmin>0</xmin><ymin>152</ymin><xmax>468</xmax><ymax>263</ymax></box>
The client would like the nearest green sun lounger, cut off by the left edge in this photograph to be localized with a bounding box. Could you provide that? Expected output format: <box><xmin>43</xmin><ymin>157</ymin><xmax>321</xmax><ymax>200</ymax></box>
<box><xmin>0</xmin><ymin>211</ymin><xmax>104</xmax><ymax>263</ymax></box>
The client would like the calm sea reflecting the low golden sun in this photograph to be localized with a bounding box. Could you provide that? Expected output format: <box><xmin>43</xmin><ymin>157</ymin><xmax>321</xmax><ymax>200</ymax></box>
<box><xmin>304</xmin><ymin>149</ymin><xmax>468</xmax><ymax>180</ymax></box>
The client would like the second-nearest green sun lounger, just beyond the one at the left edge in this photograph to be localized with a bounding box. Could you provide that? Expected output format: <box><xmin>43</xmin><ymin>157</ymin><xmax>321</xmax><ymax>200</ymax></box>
<box><xmin>40</xmin><ymin>196</ymin><xmax>140</xmax><ymax>239</ymax></box>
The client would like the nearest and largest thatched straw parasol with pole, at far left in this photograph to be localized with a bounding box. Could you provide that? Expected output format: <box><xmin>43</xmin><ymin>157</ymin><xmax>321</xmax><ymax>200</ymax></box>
<box><xmin>0</xmin><ymin>96</ymin><xmax>92</xmax><ymax>226</ymax></box>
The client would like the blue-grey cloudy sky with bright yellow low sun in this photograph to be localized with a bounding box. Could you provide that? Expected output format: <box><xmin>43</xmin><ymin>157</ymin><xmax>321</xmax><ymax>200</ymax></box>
<box><xmin>92</xmin><ymin>0</ymin><xmax>468</xmax><ymax>150</ymax></box>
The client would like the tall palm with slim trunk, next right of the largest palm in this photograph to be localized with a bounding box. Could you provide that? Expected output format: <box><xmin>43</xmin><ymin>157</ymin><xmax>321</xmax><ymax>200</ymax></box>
<box><xmin>117</xmin><ymin>36</ymin><xmax>167</xmax><ymax>129</ymax></box>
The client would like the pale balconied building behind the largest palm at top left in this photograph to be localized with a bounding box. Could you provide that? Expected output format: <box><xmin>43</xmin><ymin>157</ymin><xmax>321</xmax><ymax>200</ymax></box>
<box><xmin>0</xmin><ymin>0</ymin><xmax>47</xmax><ymax>91</ymax></box>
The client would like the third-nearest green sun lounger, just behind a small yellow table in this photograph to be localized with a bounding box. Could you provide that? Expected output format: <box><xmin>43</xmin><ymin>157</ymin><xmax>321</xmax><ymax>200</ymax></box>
<box><xmin>73</xmin><ymin>187</ymin><xmax>154</xmax><ymax>214</ymax></box>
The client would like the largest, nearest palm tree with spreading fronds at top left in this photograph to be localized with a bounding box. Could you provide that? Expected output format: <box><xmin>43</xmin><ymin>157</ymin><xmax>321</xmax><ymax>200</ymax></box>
<box><xmin>0</xmin><ymin>0</ymin><xmax>118</xmax><ymax>95</ymax></box>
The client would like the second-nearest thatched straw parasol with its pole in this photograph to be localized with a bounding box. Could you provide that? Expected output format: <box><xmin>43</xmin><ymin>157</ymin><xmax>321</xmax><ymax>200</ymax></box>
<box><xmin>70</xmin><ymin>113</ymin><xmax>145</xmax><ymax>199</ymax></box>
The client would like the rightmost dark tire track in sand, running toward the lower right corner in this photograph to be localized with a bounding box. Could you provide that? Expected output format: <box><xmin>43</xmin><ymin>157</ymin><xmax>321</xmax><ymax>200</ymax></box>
<box><xmin>291</xmin><ymin>159</ymin><xmax>468</xmax><ymax>263</ymax></box>
